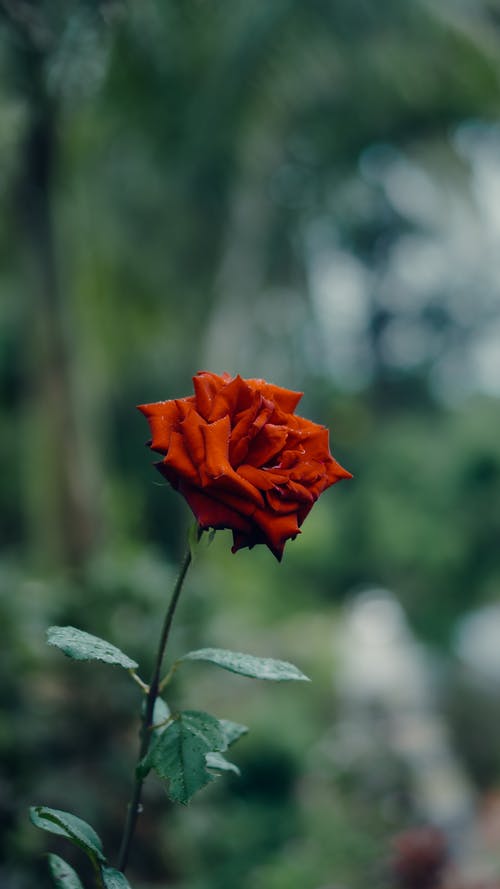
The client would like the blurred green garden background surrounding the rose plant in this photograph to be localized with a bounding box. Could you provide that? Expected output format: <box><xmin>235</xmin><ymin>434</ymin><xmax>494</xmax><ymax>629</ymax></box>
<box><xmin>0</xmin><ymin>0</ymin><xmax>500</xmax><ymax>889</ymax></box>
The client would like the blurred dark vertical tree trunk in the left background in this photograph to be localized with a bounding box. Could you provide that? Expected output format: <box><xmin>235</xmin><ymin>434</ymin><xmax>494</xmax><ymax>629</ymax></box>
<box><xmin>16</xmin><ymin>27</ymin><xmax>99</xmax><ymax>570</ymax></box>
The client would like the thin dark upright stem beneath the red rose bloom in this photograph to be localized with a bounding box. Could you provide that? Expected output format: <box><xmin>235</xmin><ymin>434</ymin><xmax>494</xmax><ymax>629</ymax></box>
<box><xmin>118</xmin><ymin>529</ymin><xmax>201</xmax><ymax>871</ymax></box>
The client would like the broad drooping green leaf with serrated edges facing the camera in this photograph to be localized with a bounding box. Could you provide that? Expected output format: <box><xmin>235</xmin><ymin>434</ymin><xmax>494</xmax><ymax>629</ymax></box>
<box><xmin>141</xmin><ymin>710</ymin><xmax>226</xmax><ymax>805</ymax></box>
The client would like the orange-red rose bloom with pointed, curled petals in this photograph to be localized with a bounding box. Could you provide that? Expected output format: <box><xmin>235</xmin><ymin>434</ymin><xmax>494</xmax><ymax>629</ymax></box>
<box><xmin>139</xmin><ymin>371</ymin><xmax>351</xmax><ymax>560</ymax></box>
